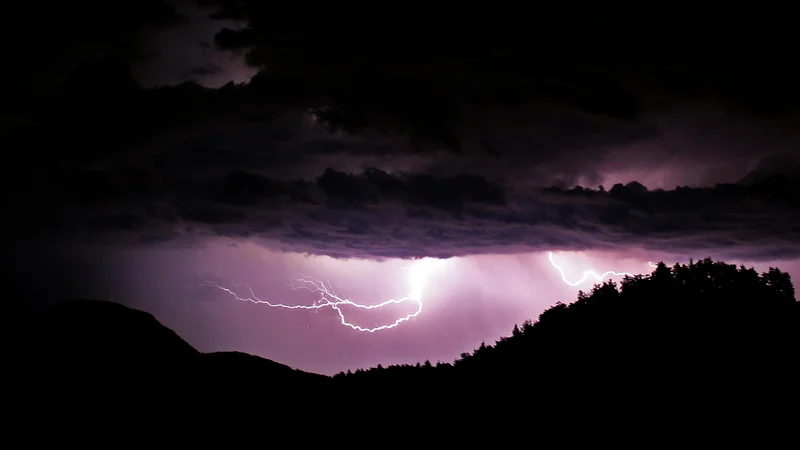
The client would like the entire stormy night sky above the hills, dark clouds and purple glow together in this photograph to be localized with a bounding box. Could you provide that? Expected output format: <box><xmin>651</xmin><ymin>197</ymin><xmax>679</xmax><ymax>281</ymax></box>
<box><xmin>0</xmin><ymin>0</ymin><xmax>800</xmax><ymax>374</ymax></box>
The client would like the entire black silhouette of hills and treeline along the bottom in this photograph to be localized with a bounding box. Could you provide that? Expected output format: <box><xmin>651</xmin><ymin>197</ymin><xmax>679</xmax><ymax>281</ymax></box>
<box><xmin>5</xmin><ymin>259</ymin><xmax>800</xmax><ymax>438</ymax></box>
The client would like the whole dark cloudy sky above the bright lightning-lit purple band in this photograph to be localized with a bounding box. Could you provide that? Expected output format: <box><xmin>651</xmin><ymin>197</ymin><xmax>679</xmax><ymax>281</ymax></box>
<box><xmin>0</xmin><ymin>0</ymin><xmax>800</xmax><ymax>298</ymax></box>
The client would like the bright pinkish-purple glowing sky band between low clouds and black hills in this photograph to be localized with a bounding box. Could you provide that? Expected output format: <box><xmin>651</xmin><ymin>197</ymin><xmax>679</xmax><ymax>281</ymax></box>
<box><xmin>32</xmin><ymin>241</ymin><xmax>800</xmax><ymax>374</ymax></box>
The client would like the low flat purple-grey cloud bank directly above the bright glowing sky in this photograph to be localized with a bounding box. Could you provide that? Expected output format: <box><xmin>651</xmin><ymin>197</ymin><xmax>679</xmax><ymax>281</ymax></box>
<box><xmin>17</xmin><ymin>156</ymin><xmax>800</xmax><ymax>259</ymax></box>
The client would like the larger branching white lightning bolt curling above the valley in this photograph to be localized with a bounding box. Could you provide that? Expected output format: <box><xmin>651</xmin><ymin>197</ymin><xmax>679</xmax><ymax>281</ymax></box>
<box><xmin>197</xmin><ymin>258</ymin><xmax>445</xmax><ymax>333</ymax></box>
